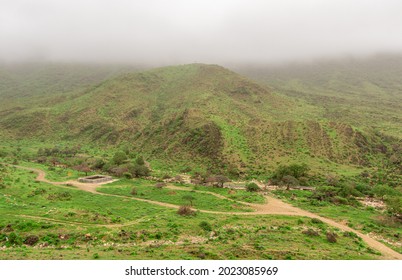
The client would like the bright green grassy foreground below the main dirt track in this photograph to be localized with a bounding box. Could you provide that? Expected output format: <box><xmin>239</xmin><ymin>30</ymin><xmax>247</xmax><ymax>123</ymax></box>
<box><xmin>0</xmin><ymin>163</ymin><xmax>386</xmax><ymax>259</ymax></box>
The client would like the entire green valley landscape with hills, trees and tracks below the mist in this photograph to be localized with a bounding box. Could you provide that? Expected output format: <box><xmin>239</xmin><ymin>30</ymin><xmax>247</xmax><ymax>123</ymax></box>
<box><xmin>0</xmin><ymin>57</ymin><xmax>402</xmax><ymax>259</ymax></box>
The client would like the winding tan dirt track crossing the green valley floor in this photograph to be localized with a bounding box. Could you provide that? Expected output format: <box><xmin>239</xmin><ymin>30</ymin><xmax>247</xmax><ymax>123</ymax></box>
<box><xmin>15</xmin><ymin>166</ymin><xmax>402</xmax><ymax>260</ymax></box>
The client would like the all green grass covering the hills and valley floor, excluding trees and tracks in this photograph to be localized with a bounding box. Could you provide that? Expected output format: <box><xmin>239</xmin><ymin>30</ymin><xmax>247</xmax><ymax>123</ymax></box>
<box><xmin>0</xmin><ymin>59</ymin><xmax>402</xmax><ymax>259</ymax></box>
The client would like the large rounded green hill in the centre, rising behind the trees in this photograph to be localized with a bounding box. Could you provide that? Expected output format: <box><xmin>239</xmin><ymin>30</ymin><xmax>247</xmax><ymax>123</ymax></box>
<box><xmin>0</xmin><ymin>64</ymin><xmax>401</xmax><ymax>175</ymax></box>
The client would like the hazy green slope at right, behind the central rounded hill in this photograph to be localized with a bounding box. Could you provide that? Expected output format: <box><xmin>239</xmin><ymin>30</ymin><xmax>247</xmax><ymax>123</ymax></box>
<box><xmin>236</xmin><ymin>55</ymin><xmax>402</xmax><ymax>138</ymax></box>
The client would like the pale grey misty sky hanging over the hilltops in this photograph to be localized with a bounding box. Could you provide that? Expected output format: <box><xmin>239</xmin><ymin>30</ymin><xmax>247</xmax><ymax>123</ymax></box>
<box><xmin>0</xmin><ymin>0</ymin><xmax>402</xmax><ymax>65</ymax></box>
